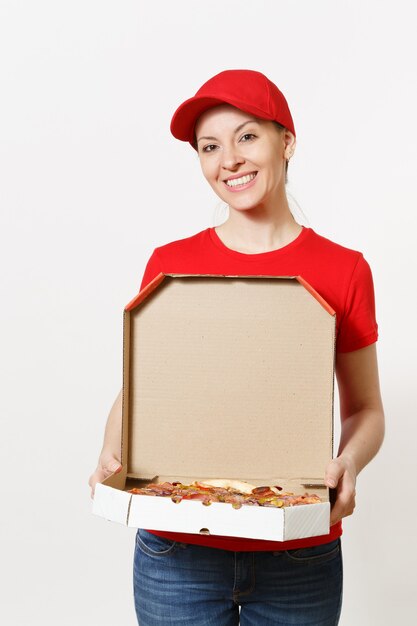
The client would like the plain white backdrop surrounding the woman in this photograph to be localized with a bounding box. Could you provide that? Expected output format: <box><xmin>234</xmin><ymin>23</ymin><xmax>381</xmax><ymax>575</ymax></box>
<box><xmin>0</xmin><ymin>0</ymin><xmax>417</xmax><ymax>626</ymax></box>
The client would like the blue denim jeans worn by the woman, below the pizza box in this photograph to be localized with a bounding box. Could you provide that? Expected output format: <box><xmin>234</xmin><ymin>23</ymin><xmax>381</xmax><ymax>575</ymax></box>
<box><xmin>134</xmin><ymin>529</ymin><xmax>343</xmax><ymax>626</ymax></box>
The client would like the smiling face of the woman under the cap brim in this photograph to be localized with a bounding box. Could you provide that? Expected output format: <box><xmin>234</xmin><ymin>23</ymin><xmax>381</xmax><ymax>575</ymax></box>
<box><xmin>195</xmin><ymin>104</ymin><xmax>295</xmax><ymax>210</ymax></box>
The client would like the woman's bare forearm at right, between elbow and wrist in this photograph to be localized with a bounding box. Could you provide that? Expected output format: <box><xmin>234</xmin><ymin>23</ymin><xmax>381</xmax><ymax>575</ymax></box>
<box><xmin>338</xmin><ymin>406</ymin><xmax>385</xmax><ymax>475</ymax></box>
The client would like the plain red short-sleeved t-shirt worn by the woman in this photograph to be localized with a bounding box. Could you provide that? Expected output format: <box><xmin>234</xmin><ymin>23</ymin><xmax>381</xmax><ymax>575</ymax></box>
<box><xmin>136</xmin><ymin>227</ymin><xmax>378</xmax><ymax>551</ymax></box>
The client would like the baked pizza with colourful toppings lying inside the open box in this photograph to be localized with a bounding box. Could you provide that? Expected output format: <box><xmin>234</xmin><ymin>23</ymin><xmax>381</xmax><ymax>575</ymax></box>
<box><xmin>129</xmin><ymin>479</ymin><xmax>322</xmax><ymax>509</ymax></box>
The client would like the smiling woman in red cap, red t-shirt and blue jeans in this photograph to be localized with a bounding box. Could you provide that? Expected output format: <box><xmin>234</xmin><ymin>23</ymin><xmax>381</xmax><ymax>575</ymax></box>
<box><xmin>90</xmin><ymin>70</ymin><xmax>384</xmax><ymax>626</ymax></box>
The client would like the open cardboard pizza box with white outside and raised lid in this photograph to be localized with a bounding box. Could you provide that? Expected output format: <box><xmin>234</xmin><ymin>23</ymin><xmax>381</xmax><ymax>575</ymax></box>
<box><xmin>93</xmin><ymin>273</ymin><xmax>335</xmax><ymax>541</ymax></box>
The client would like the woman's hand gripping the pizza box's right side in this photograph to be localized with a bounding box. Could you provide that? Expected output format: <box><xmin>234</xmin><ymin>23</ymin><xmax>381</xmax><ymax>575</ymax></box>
<box><xmin>324</xmin><ymin>454</ymin><xmax>356</xmax><ymax>526</ymax></box>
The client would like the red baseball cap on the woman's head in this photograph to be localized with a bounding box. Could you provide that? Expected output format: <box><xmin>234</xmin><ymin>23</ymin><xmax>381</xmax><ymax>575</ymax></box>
<box><xmin>167</xmin><ymin>70</ymin><xmax>295</xmax><ymax>148</ymax></box>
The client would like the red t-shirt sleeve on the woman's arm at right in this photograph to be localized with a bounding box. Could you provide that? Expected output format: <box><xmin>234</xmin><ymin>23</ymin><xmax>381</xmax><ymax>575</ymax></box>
<box><xmin>336</xmin><ymin>254</ymin><xmax>378</xmax><ymax>352</ymax></box>
